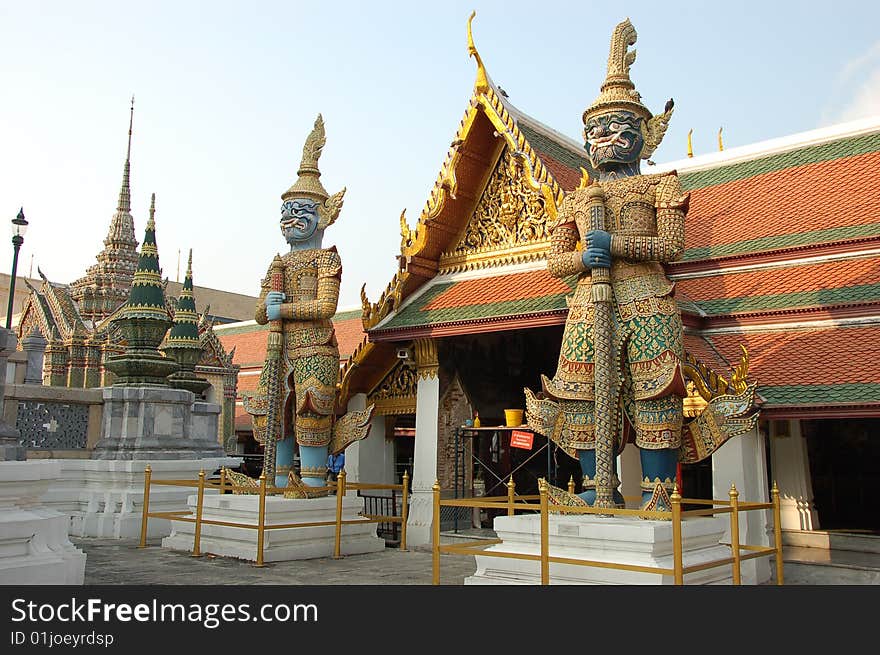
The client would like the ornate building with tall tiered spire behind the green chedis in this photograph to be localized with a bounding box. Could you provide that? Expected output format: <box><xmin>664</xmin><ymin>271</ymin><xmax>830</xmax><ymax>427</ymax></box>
<box><xmin>14</xmin><ymin>104</ymin><xmax>256</xmax><ymax>452</ymax></box>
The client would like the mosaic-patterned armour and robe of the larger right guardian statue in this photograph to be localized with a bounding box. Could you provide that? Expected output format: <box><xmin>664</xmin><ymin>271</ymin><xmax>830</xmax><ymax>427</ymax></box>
<box><xmin>542</xmin><ymin>172</ymin><xmax>688</xmax><ymax>450</ymax></box>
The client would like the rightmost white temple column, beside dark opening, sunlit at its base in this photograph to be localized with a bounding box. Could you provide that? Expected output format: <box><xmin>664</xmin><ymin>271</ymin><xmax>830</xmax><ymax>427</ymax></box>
<box><xmin>770</xmin><ymin>420</ymin><xmax>819</xmax><ymax>530</ymax></box>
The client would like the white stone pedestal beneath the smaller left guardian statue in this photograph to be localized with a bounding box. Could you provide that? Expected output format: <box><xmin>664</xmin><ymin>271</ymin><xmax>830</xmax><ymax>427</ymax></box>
<box><xmin>162</xmin><ymin>494</ymin><xmax>385</xmax><ymax>562</ymax></box>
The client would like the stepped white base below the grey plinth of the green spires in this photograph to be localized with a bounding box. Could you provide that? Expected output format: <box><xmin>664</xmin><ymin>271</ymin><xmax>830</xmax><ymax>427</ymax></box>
<box><xmin>42</xmin><ymin>457</ymin><xmax>241</xmax><ymax>539</ymax></box>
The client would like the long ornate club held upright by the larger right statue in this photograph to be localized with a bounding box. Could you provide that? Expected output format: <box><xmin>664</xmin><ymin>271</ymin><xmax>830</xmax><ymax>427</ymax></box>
<box><xmin>587</xmin><ymin>182</ymin><xmax>617</xmax><ymax>508</ymax></box>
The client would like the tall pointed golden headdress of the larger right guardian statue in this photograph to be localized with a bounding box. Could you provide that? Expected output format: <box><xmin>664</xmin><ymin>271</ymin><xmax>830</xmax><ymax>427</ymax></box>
<box><xmin>583</xmin><ymin>18</ymin><xmax>674</xmax><ymax>159</ymax></box>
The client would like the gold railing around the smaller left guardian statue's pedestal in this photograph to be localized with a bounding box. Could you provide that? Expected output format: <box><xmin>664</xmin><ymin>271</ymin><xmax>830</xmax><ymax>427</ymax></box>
<box><xmin>138</xmin><ymin>466</ymin><xmax>409</xmax><ymax>566</ymax></box>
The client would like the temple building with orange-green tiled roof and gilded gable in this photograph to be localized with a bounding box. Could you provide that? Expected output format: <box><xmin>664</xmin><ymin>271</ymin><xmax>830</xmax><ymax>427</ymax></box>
<box><xmin>216</xmin><ymin>30</ymin><xmax>880</xmax><ymax>545</ymax></box>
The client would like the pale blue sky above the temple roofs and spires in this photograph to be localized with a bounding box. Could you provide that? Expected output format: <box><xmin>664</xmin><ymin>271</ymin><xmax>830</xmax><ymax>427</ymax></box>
<box><xmin>0</xmin><ymin>0</ymin><xmax>880</xmax><ymax>309</ymax></box>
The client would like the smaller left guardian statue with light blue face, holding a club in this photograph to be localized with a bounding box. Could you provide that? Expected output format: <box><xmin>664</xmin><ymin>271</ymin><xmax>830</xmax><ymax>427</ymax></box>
<box><xmin>244</xmin><ymin>114</ymin><xmax>373</xmax><ymax>497</ymax></box>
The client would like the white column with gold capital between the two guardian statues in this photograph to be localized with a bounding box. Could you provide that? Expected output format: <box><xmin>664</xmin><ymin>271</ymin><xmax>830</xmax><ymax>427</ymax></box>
<box><xmin>407</xmin><ymin>339</ymin><xmax>440</xmax><ymax>546</ymax></box>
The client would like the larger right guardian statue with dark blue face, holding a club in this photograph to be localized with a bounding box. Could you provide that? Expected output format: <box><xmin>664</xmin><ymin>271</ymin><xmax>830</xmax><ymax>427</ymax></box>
<box><xmin>525</xmin><ymin>19</ymin><xmax>757</xmax><ymax>510</ymax></box>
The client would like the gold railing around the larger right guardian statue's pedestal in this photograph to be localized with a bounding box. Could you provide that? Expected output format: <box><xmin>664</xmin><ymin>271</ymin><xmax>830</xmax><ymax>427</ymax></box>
<box><xmin>432</xmin><ymin>478</ymin><xmax>784</xmax><ymax>585</ymax></box>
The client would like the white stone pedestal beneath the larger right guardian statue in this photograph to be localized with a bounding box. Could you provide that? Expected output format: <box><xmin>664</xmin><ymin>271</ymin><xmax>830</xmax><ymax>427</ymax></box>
<box><xmin>464</xmin><ymin>514</ymin><xmax>733</xmax><ymax>585</ymax></box>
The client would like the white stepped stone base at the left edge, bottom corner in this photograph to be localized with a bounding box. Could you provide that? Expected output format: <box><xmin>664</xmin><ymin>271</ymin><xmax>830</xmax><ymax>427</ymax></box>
<box><xmin>0</xmin><ymin>460</ymin><xmax>86</xmax><ymax>585</ymax></box>
